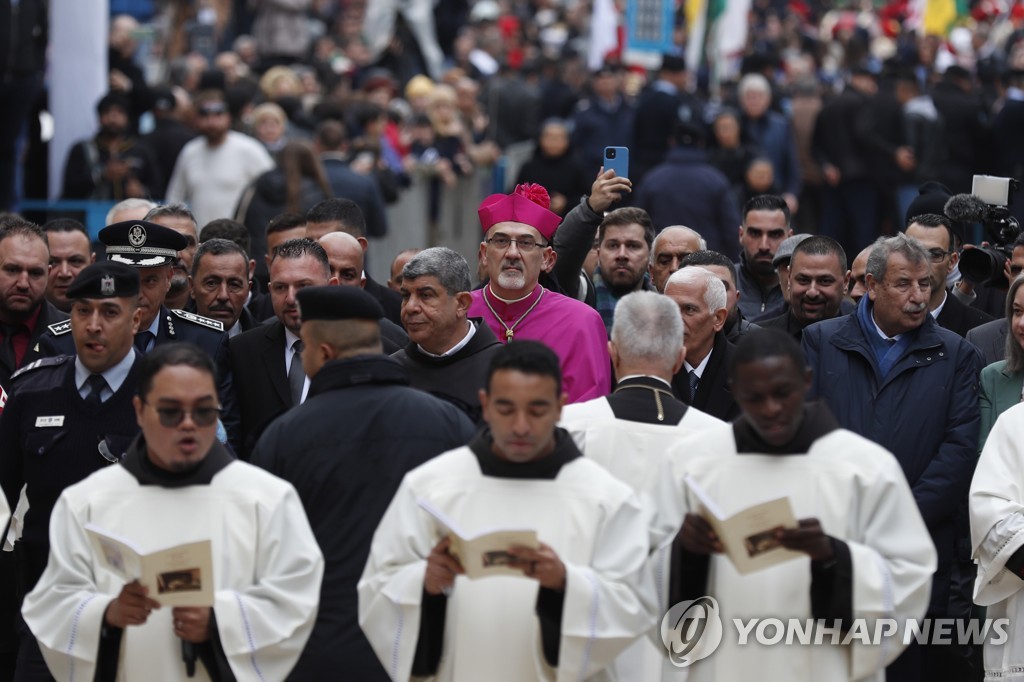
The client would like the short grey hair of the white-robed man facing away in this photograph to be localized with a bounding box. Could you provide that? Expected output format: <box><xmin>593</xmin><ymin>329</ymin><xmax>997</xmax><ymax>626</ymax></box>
<box><xmin>611</xmin><ymin>291</ymin><xmax>683</xmax><ymax>373</ymax></box>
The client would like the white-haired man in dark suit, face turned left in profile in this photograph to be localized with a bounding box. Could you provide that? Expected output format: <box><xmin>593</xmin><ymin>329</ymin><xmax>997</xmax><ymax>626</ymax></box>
<box><xmin>665</xmin><ymin>267</ymin><xmax>739</xmax><ymax>421</ymax></box>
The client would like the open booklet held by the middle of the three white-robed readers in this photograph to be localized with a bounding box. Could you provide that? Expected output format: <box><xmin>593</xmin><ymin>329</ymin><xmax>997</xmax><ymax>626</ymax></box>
<box><xmin>417</xmin><ymin>500</ymin><xmax>541</xmax><ymax>580</ymax></box>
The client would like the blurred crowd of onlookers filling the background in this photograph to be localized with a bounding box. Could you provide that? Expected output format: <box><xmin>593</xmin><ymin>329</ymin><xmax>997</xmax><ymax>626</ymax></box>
<box><xmin>0</xmin><ymin>0</ymin><xmax>1024</xmax><ymax>261</ymax></box>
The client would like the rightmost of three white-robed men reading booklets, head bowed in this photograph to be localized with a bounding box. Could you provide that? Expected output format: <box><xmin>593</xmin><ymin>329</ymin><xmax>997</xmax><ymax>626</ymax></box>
<box><xmin>673</xmin><ymin>330</ymin><xmax>936</xmax><ymax>682</ymax></box>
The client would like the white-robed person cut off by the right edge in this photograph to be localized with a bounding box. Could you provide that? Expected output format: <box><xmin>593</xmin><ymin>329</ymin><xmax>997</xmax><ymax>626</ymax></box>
<box><xmin>970</xmin><ymin>404</ymin><xmax>1024</xmax><ymax>671</ymax></box>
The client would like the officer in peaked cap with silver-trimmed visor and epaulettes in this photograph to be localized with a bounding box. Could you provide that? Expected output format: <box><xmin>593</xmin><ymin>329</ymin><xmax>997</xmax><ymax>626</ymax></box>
<box><xmin>40</xmin><ymin>220</ymin><xmax>239</xmax><ymax>447</ymax></box>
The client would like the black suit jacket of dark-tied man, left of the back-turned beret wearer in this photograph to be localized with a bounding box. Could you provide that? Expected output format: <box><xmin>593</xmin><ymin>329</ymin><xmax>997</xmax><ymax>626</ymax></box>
<box><xmin>230</xmin><ymin>319</ymin><xmax>292</xmax><ymax>460</ymax></box>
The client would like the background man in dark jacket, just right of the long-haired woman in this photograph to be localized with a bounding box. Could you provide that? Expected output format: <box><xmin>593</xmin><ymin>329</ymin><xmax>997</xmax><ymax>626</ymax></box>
<box><xmin>313</xmin><ymin>119</ymin><xmax>387</xmax><ymax>237</ymax></box>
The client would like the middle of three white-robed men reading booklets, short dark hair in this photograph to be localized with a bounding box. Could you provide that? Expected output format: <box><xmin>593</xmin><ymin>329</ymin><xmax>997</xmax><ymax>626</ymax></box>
<box><xmin>358</xmin><ymin>341</ymin><xmax>657</xmax><ymax>682</ymax></box>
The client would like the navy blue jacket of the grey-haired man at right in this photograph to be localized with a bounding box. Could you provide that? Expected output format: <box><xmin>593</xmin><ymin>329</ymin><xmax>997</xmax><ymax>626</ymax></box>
<box><xmin>803</xmin><ymin>296</ymin><xmax>982</xmax><ymax>614</ymax></box>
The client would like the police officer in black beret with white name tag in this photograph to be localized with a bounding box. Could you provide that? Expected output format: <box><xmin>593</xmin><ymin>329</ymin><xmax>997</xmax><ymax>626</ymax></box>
<box><xmin>0</xmin><ymin>262</ymin><xmax>142</xmax><ymax>681</ymax></box>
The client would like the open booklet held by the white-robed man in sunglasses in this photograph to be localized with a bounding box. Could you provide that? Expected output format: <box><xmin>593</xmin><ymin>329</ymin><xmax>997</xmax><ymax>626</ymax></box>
<box><xmin>85</xmin><ymin>523</ymin><xmax>214</xmax><ymax>606</ymax></box>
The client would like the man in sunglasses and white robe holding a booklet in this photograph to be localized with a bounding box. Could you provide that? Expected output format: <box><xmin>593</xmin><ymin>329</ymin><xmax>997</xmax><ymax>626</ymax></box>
<box><xmin>23</xmin><ymin>344</ymin><xmax>324</xmax><ymax>682</ymax></box>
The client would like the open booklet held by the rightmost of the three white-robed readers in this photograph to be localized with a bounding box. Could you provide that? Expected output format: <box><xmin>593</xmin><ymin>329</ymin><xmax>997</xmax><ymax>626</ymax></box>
<box><xmin>684</xmin><ymin>475</ymin><xmax>807</xmax><ymax>576</ymax></box>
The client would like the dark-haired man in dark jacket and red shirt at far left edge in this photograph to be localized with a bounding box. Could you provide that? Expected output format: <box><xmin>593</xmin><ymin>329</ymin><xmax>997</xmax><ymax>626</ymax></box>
<box><xmin>0</xmin><ymin>215</ymin><xmax>67</xmax><ymax>389</ymax></box>
